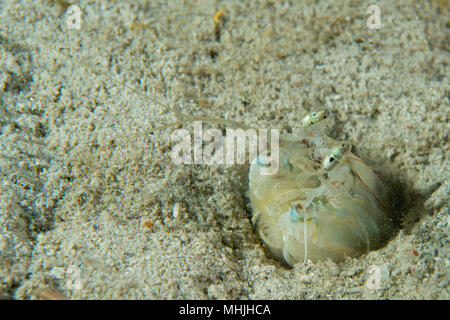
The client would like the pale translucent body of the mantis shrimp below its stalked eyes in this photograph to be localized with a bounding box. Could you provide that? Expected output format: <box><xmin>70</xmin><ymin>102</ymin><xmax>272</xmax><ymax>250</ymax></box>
<box><xmin>249</xmin><ymin>127</ymin><xmax>393</xmax><ymax>265</ymax></box>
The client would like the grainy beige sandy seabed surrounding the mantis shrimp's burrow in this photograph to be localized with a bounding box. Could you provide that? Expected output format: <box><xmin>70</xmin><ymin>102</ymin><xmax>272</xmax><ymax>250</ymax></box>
<box><xmin>0</xmin><ymin>0</ymin><xmax>450</xmax><ymax>299</ymax></box>
